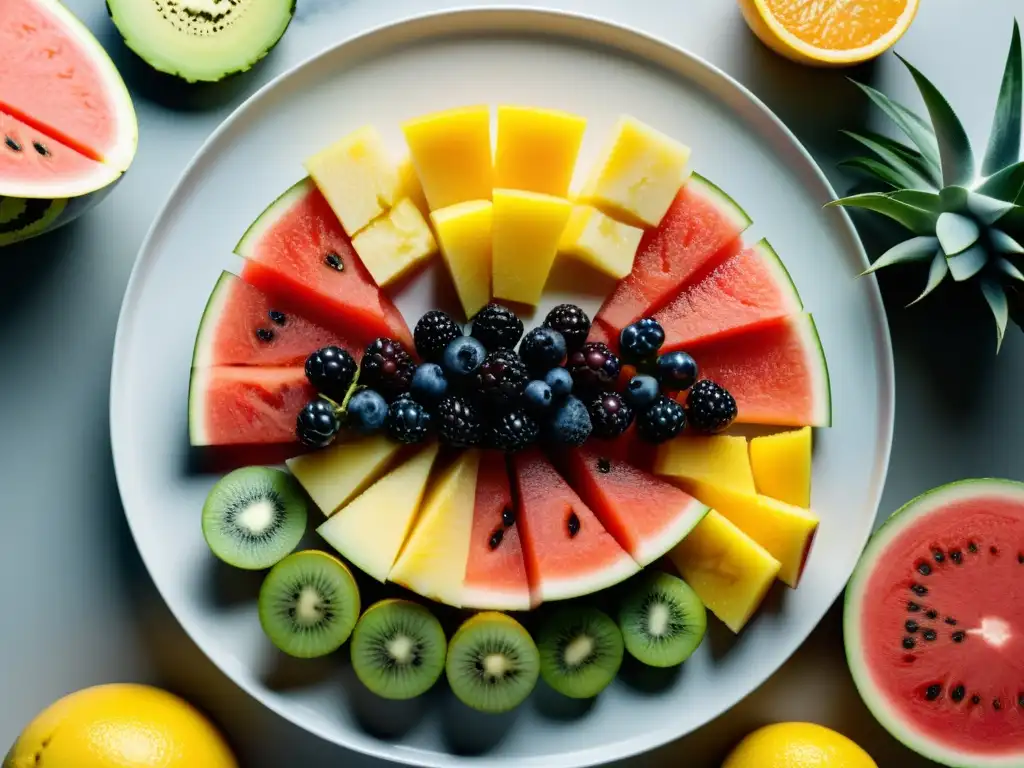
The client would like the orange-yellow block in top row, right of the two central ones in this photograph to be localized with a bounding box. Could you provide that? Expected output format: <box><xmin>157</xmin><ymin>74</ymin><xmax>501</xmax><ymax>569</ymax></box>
<box><xmin>495</xmin><ymin>104</ymin><xmax>587</xmax><ymax>198</ymax></box>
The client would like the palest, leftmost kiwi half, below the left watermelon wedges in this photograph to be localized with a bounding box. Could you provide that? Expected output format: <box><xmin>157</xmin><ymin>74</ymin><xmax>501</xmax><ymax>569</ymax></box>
<box><xmin>203</xmin><ymin>467</ymin><xmax>308</xmax><ymax>570</ymax></box>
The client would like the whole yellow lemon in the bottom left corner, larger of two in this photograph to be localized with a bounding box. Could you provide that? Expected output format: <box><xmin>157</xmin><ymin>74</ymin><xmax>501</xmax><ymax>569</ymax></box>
<box><xmin>3</xmin><ymin>684</ymin><xmax>239</xmax><ymax>768</ymax></box>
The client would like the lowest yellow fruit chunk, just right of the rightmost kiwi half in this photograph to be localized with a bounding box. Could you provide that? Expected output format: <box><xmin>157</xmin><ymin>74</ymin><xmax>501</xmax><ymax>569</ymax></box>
<box><xmin>669</xmin><ymin>510</ymin><xmax>780</xmax><ymax>633</ymax></box>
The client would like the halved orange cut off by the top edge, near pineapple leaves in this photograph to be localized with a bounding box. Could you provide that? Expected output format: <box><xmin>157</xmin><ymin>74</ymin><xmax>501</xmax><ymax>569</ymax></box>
<box><xmin>739</xmin><ymin>0</ymin><xmax>920</xmax><ymax>67</ymax></box>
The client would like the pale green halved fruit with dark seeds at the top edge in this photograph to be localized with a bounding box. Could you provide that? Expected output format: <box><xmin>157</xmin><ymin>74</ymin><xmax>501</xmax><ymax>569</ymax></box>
<box><xmin>106</xmin><ymin>0</ymin><xmax>295</xmax><ymax>82</ymax></box>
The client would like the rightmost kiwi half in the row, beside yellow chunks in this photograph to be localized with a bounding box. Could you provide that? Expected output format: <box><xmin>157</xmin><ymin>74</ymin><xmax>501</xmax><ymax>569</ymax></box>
<box><xmin>618</xmin><ymin>573</ymin><xmax>708</xmax><ymax>667</ymax></box>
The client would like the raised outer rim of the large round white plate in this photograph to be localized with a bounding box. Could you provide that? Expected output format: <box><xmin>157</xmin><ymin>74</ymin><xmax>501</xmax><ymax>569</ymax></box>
<box><xmin>109</xmin><ymin>4</ymin><xmax>896</xmax><ymax>768</ymax></box>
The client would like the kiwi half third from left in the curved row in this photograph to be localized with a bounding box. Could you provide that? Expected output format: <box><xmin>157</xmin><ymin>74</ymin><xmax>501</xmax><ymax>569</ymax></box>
<box><xmin>352</xmin><ymin>600</ymin><xmax>447</xmax><ymax>699</ymax></box>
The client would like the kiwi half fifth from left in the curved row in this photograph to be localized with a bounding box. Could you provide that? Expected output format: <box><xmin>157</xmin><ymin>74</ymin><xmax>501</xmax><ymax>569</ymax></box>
<box><xmin>537</xmin><ymin>606</ymin><xmax>623</xmax><ymax>698</ymax></box>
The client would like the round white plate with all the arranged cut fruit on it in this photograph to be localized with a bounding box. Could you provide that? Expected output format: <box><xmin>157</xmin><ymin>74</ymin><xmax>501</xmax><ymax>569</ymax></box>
<box><xmin>112</xmin><ymin>13</ymin><xmax>892</xmax><ymax>765</ymax></box>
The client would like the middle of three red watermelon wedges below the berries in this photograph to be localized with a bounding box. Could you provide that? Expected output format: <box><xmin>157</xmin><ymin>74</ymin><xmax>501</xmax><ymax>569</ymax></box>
<box><xmin>512</xmin><ymin>449</ymin><xmax>640</xmax><ymax>604</ymax></box>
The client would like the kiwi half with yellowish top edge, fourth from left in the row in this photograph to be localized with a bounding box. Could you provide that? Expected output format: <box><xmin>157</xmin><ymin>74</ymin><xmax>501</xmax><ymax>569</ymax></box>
<box><xmin>445</xmin><ymin>611</ymin><xmax>541</xmax><ymax>714</ymax></box>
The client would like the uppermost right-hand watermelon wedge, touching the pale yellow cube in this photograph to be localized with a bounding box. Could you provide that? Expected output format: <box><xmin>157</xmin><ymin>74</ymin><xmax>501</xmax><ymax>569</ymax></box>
<box><xmin>595</xmin><ymin>173</ymin><xmax>751</xmax><ymax>339</ymax></box>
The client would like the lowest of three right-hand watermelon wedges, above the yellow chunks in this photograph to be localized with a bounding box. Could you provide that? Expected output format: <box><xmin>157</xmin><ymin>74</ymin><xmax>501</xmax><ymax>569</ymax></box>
<box><xmin>688</xmin><ymin>313</ymin><xmax>831</xmax><ymax>434</ymax></box>
